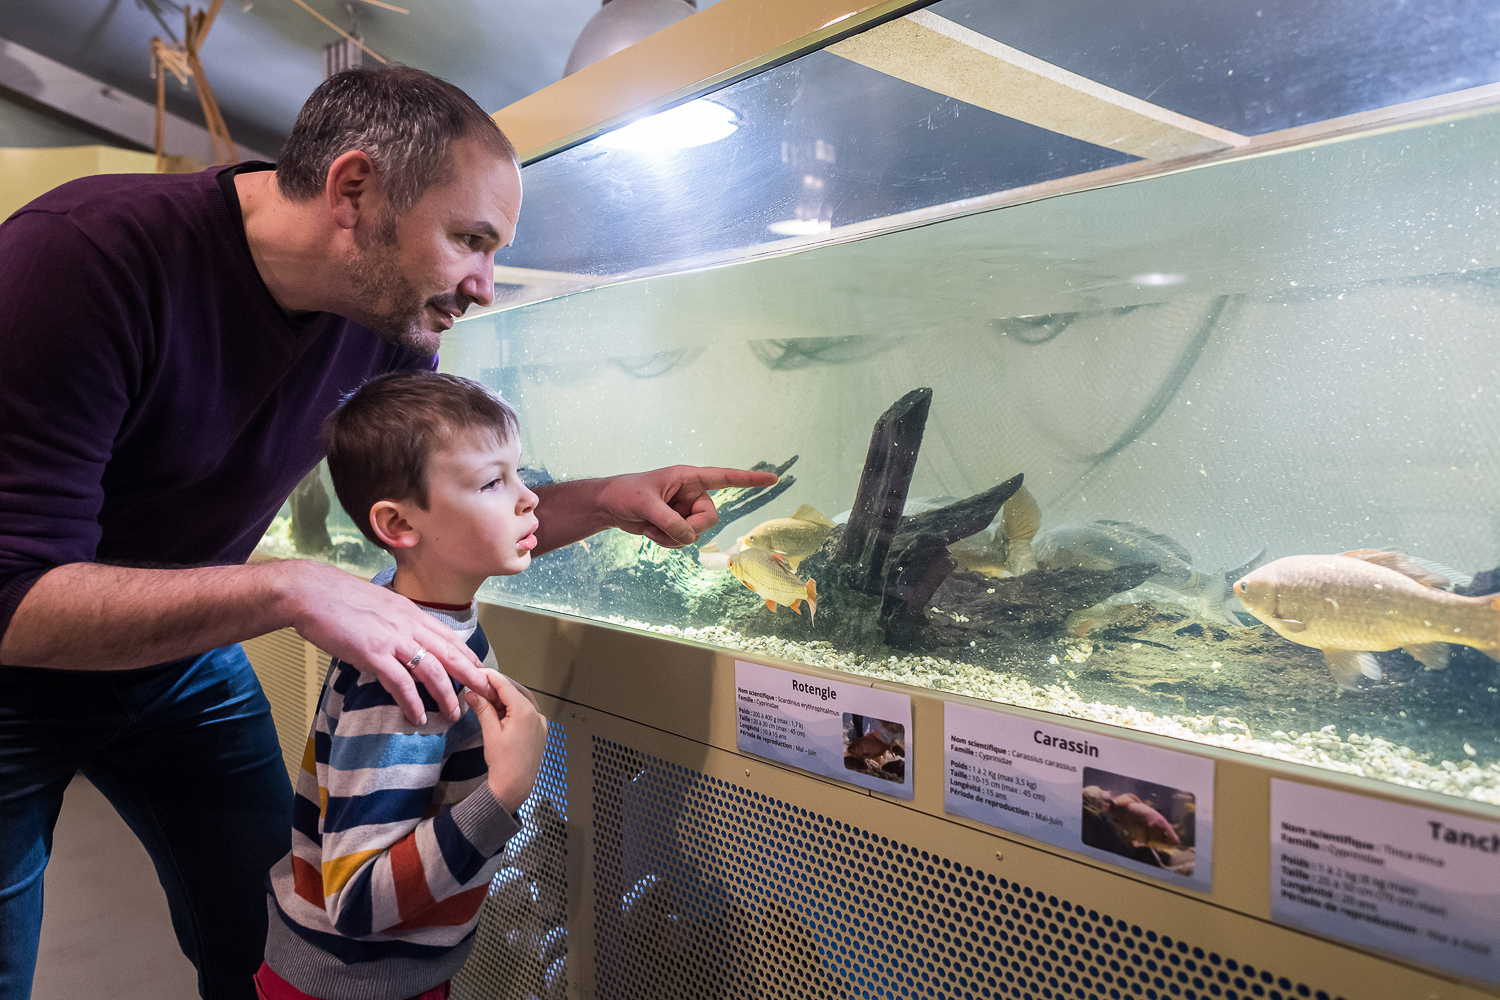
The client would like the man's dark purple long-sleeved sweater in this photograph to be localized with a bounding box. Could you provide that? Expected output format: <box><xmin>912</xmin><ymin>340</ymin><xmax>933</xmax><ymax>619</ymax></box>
<box><xmin>0</xmin><ymin>165</ymin><xmax>435</xmax><ymax>653</ymax></box>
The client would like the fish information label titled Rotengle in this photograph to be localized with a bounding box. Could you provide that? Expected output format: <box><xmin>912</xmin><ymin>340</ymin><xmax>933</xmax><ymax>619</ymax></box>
<box><xmin>735</xmin><ymin>660</ymin><xmax>912</xmax><ymax>799</ymax></box>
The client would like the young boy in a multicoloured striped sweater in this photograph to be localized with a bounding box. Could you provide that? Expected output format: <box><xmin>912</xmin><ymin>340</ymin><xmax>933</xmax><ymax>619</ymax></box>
<box><xmin>255</xmin><ymin>372</ymin><xmax>548</xmax><ymax>1000</ymax></box>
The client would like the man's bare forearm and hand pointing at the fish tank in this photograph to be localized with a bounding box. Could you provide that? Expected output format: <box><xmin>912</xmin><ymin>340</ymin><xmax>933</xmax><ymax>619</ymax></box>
<box><xmin>536</xmin><ymin>465</ymin><xmax>776</xmax><ymax>553</ymax></box>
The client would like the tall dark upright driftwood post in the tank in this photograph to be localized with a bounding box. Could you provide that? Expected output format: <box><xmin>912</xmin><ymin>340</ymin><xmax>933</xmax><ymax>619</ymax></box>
<box><xmin>834</xmin><ymin>388</ymin><xmax>933</xmax><ymax>594</ymax></box>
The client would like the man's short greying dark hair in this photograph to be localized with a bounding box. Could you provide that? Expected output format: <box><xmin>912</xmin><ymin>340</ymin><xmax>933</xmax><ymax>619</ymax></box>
<box><xmin>276</xmin><ymin>66</ymin><xmax>516</xmax><ymax>214</ymax></box>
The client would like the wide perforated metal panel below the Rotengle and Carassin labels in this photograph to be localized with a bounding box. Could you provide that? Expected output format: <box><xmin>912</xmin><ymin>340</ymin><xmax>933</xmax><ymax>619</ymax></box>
<box><xmin>593</xmin><ymin>738</ymin><xmax>1350</xmax><ymax>1000</ymax></box>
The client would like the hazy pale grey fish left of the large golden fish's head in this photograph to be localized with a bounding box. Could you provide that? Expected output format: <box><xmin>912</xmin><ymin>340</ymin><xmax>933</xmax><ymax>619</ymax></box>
<box><xmin>1032</xmin><ymin>520</ymin><xmax>1241</xmax><ymax>627</ymax></box>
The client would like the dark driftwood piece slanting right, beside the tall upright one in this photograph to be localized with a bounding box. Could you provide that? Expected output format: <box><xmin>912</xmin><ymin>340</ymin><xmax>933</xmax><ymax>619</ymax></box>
<box><xmin>881</xmin><ymin>474</ymin><xmax>1022</xmax><ymax>630</ymax></box>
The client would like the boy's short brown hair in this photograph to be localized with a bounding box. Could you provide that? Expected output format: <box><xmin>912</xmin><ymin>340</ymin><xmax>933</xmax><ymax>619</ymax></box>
<box><xmin>323</xmin><ymin>372</ymin><xmax>521</xmax><ymax>549</ymax></box>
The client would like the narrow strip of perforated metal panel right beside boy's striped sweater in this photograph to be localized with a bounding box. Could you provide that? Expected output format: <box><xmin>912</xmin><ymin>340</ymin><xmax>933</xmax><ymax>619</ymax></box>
<box><xmin>453</xmin><ymin>720</ymin><xmax>567</xmax><ymax>1000</ymax></box>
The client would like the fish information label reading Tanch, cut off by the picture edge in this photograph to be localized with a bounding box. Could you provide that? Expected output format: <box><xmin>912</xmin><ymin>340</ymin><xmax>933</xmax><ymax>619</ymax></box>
<box><xmin>1271</xmin><ymin>780</ymin><xmax>1500</xmax><ymax>984</ymax></box>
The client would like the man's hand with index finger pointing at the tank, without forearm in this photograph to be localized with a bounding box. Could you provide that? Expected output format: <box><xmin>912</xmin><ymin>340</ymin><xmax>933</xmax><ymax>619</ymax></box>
<box><xmin>591</xmin><ymin>465</ymin><xmax>777</xmax><ymax>549</ymax></box>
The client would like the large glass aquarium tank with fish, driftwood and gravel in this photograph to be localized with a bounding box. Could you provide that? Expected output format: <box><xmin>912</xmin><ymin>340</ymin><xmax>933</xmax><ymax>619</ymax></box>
<box><xmin>263</xmin><ymin>0</ymin><xmax>1500</xmax><ymax>804</ymax></box>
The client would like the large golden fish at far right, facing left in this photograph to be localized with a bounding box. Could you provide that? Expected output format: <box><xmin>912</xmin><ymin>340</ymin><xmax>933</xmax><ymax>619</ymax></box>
<box><xmin>1235</xmin><ymin>549</ymin><xmax>1500</xmax><ymax>691</ymax></box>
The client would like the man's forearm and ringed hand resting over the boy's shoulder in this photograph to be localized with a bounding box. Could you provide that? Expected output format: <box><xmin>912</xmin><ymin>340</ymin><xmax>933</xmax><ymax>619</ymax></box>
<box><xmin>0</xmin><ymin>559</ymin><xmax>486</xmax><ymax>721</ymax></box>
